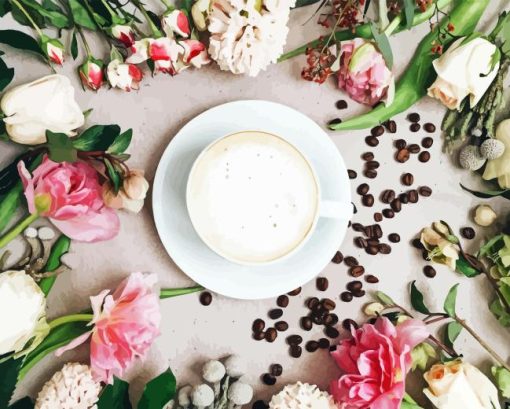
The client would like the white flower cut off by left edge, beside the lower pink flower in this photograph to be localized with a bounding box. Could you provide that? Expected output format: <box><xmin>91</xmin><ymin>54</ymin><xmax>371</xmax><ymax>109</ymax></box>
<box><xmin>0</xmin><ymin>271</ymin><xmax>46</xmax><ymax>355</ymax></box>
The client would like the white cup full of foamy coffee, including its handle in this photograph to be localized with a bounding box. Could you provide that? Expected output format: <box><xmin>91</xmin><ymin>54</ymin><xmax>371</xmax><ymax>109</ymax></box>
<box><xmin>186</xmin><ymin>131</ymin><xmax>352</xmax><ymax>265</ymax></box>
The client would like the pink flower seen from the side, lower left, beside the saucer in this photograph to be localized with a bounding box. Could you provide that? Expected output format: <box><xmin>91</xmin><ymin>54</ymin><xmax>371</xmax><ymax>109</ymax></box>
<box><xmin>56</xmin><ymin>273</ymin><xmax>161</xmax><ymax>384</ymax></box>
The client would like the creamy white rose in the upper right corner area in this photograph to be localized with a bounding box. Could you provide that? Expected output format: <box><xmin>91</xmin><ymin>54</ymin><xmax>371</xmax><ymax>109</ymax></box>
<box><xmin>428</xmin><ymin>37</ymin><xmax>499</xmax><ymax>109</ymax></box>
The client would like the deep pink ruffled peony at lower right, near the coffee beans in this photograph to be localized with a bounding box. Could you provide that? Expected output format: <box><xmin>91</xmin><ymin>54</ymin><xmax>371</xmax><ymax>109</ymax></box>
<box><xmin>331</xmin><ymin>318</ymin><xmax>429</xmax><ymax>409</ymax></box>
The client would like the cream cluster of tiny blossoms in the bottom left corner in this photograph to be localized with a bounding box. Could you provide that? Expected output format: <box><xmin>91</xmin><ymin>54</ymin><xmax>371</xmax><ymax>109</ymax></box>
<box><xmin>35</xmin><ymin>362</ymin><xmax>101</xmax><ymax>409</ymax></box>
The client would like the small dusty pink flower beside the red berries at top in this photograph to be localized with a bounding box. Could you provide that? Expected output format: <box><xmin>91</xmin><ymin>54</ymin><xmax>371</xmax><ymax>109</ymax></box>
<box><xmin>337</xmin><ymin>38</ymin><xmax>395</xmax><ymax>105</ymax></box>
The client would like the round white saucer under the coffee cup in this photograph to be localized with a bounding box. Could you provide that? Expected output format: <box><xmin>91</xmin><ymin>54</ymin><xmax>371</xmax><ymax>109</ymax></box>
<box><xmin>153</xmin><ymin>101</ymin><xmax>351</xmax><ymax>299</ymax></box>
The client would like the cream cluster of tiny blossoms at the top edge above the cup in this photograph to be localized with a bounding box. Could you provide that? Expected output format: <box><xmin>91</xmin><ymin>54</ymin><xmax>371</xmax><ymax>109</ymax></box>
<box><xmin>208</xmin><ymin>0</ymin><xmax>295</xmax><ymax>77</ymax></box>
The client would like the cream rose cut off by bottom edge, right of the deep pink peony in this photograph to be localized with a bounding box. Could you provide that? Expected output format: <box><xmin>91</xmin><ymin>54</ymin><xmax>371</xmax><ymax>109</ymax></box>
<box><xmin>423</xmin><ymin>361</ymin><xmax>501</xmax><ymax>409</ymax></box>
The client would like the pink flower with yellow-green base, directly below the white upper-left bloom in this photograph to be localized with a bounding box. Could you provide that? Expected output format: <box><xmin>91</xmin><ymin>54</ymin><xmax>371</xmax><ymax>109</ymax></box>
<box><xmin>18</xmin><ymin>156</ymin><xmax>120</xmax><ymax>242</ymax></box>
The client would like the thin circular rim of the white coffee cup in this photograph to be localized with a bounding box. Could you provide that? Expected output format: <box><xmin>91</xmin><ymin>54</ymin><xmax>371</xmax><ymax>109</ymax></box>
<box><xmin>186</xmin><ymin>130</ymin><xmax>322</xmax><ymax>266</ymax></box>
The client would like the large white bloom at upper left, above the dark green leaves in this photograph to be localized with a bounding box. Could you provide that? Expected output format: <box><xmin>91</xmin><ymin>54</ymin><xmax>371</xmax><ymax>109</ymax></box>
<box><xmin>0</xmin><ymin>74</ymin><xmax>85</xmax><ymax>145</ymax></box>
